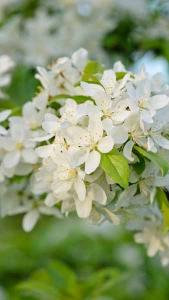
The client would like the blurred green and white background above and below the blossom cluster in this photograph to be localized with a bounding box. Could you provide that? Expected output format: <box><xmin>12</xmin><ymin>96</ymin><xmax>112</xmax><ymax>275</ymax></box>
<box><xmin>0</xmin><ymin>0</ymin><xmax>169</xmax><ymax>300</ymax></box>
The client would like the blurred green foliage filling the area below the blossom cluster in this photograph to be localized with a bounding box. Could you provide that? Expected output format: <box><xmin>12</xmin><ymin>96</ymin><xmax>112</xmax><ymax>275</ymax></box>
<box><xmin>0</xmin><ymin>218</ymin><xmax>169</xmax><ymax>300</ymax></box>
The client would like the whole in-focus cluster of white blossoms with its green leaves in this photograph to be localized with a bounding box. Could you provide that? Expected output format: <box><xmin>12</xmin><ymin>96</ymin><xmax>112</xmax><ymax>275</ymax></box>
<box><xmin>0</xmin><ymin>49</ymin><xmax>169</xmax><ymax>264</ymax></box>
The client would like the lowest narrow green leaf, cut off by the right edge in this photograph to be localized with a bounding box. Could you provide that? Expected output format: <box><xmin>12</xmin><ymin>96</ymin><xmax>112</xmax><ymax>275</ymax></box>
<box><xmin>156</xmin><ymin>188</ymin><xmax>169</xmax><ymax>231</ymax></box>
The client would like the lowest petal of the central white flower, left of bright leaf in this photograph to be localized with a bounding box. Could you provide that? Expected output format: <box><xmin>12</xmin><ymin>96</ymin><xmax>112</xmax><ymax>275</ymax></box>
<box><xmin>85</xmin><ymin>150</ymin><xmax>101</xmax><ymax>174</ymax></box>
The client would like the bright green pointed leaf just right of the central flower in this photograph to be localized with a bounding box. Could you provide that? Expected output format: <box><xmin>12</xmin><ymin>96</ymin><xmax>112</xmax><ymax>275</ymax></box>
<box><xmin>101</xmin><ymin>149</ymin><xmax>129</xmax><ymax>188</ymax></box>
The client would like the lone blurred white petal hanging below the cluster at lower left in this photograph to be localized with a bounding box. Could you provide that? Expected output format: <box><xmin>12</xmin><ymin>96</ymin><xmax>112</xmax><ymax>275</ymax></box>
<box><xmin>22</xmin><ymin>209</ymin><xmax>39</xmax><ymax>232</ymax></box>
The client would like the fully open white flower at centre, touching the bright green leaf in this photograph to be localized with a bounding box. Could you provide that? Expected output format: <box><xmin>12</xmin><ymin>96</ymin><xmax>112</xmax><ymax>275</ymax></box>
<box><xmin>65</xmin><ymin>115</ymin><xmax>114</xmax><ymax>174</ymax></box>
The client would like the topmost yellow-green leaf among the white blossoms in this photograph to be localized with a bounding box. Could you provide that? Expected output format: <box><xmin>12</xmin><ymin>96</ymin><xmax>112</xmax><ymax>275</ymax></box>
<box><xmin>81</xmin><ymin>60</ymin><xmax>103</xmax><ymax>83</ymax></box>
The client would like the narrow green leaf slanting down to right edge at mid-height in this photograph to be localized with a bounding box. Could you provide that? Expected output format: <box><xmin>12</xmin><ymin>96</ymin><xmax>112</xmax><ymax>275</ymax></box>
<box><xmin>134</xmin><ymin>146</ymin><xmax>169</xmax><ymax>176</ymax></box>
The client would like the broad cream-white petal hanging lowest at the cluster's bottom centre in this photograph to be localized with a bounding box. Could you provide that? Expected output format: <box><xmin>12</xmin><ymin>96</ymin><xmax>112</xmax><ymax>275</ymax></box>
<box><xmin>75</xmin><ymin>196</ymin><xmax>92</xmax><ymax>218</ymax></box>
